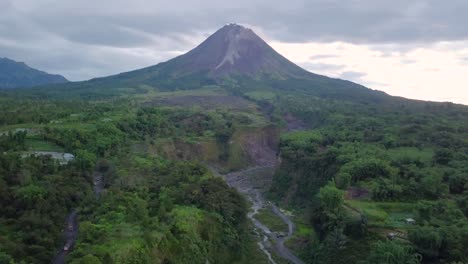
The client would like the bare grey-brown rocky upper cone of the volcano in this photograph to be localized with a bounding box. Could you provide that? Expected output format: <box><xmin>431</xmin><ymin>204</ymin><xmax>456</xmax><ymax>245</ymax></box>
<box><xmin>159</xmin><ymin>24</ymin><xmax>309</xmax><ymax>79</ymax></box>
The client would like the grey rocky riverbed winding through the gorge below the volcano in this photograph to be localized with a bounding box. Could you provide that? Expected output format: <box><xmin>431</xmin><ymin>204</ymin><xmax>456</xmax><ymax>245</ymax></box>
<box><xmin>224</xmin><ymin>166</ymin><xmax>304</xmax><ymax>264</ymax></box>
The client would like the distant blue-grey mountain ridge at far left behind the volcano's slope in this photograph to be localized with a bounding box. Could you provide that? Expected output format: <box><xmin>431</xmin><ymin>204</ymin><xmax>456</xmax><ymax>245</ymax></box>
<box><xmin>0</xmin><ymin>58</ymin><xmax>68</xmax><ymax>89</ymax></box>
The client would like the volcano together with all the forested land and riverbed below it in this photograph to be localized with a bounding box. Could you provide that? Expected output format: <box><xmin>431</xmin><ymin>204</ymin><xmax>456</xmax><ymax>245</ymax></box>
<box><xmin>0</xmin><ymin>24</ymin><xmax>468</xmax><ymax>264</ymax></box>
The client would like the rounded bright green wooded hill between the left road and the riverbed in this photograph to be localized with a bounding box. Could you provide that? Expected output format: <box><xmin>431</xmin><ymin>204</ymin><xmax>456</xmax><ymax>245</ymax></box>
<box><xmin>71</xmin><ymin>159</ymin><xmax>256</xmax><ymax>263</ymax></box>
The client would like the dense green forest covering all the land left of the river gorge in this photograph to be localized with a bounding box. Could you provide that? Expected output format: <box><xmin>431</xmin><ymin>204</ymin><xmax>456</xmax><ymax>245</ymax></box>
<box><xmin>0</xmin><ymin>100</ymin><xmax>263</xmax><ymax>263</ymax></box>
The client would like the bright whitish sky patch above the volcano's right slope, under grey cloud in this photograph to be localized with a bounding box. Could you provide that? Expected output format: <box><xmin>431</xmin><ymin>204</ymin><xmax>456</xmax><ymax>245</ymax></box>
<box><xmin>271</xmin><ymin>41</ymin><xmax>468</xmax><ymax>104</ymax></box>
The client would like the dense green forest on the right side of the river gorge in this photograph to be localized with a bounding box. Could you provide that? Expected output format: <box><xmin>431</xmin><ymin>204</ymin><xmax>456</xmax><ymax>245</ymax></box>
<box><xmin>270</xmin><ymin>94</ymin><xmax>468</xmax><ymax>263</ymax></box>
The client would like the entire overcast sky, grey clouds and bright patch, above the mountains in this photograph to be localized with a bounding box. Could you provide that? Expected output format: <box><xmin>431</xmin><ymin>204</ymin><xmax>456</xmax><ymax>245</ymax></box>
<box><xmin>0</xmin><ymin>0</ymin><xmax>468</xmax><ymax>104</ymax></box>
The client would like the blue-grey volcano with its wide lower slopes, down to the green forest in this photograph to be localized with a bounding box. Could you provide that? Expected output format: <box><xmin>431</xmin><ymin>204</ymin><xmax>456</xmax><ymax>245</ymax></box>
<box><xmin>16</xmin><ymin>24</ymin><xmax>390</xmax><ymax>103</ymax></box>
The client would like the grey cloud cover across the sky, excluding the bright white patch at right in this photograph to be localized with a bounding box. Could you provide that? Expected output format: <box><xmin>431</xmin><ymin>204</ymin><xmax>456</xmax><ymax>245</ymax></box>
<box><xmin>0</xmin><ymin>0</ymin><xmax>468</xmax><ymax>80</ymax></box>
